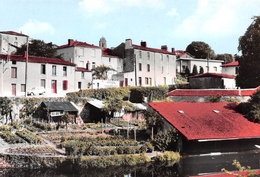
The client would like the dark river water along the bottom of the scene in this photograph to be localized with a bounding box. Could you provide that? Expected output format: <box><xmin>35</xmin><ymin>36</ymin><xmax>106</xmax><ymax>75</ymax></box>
<box><xmin>0</xmin><ymin>150</ymin><xmax>260</xmax><ymax>177</ymax></box>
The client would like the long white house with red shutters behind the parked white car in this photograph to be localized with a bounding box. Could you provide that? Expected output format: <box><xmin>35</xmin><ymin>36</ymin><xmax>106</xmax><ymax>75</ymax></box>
<box><xmin>0</xmin><ymin>54</ymin><xmax>75</xmax><ymax>96</ymax></box>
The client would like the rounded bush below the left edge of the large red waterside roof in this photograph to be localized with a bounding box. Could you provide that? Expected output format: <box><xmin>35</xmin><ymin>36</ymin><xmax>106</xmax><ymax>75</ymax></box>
<box><xmin>152</xmin><ymin>129</ymin><xmax>177</xmax><ymax>151</ymax></box>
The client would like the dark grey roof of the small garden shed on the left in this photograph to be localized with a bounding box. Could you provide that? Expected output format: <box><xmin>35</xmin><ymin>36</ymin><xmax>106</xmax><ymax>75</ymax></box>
<box><xmin>42</xmin><ymin>101</ymin><xmax>78</xmax><ymax>112</ymax></box>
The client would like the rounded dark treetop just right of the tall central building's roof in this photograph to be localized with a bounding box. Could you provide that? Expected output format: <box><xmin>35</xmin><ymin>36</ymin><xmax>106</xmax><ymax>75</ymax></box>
<box><xmin>186</xmin><ymin>41</ymin><xmax>216</xmax><ymax>59</ymax></box>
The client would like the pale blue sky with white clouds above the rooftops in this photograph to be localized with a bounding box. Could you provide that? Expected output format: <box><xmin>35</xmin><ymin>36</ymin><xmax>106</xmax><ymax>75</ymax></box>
<box><xmin>0</xmin><ymin>0</ymin><xmax>260</xmax><ymax>54</ymax></box>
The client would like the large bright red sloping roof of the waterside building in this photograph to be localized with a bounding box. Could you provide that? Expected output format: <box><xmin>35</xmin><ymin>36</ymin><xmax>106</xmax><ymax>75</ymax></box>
<box><xmin>149</xmin><ymin>102</ymin><xmax>260</xmax><ymax>140</ymax></box>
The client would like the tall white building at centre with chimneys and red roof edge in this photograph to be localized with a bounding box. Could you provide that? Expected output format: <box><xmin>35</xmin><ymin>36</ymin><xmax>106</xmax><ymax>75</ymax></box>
<box><xmin>113</xmin><ymin>39</ymin><xmax>176</xmax><ymax>86</ymax></box>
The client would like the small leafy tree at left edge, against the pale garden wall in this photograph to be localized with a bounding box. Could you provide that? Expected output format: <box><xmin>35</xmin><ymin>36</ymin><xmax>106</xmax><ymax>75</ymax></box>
<box><xmin>0</xmin><ymin>97</ymin><xmax>13</xmax><ymax>124</ymax></box>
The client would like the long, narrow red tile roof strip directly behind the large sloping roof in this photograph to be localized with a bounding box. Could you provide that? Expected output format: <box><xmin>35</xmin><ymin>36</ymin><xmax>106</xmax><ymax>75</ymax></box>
<box><xmin>167</xmin><ymin>87</ymin><xmax>260</xmax><ymax>96</ymax></box>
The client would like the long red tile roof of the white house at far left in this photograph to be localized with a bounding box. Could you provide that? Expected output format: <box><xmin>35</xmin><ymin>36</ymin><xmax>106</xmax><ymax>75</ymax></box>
<box><xmin>0</xmin><ymin>54</ymin><xmax>75</xmax><ymax>66</ymax></box>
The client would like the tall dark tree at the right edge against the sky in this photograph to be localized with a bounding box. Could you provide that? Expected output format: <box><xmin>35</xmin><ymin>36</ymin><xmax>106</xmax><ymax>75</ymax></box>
<box><xmin>236</xmin><ymin>16</ymin><xmax>260</xmax><ymax>88</ymax></box>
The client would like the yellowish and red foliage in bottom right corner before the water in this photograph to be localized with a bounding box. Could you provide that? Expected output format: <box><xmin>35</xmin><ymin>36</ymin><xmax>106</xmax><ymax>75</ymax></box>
<box><xmin>221</xmin><ymin>160</ymin><xmax>260</xmax><ymax>177</ymax></box>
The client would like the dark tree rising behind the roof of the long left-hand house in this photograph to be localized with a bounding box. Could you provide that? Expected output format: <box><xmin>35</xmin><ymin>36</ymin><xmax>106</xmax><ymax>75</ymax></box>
<box><xmin>15</xmin><ymin>40</ymin><xmax>62</xmax><ymax>59</ymax></box>
